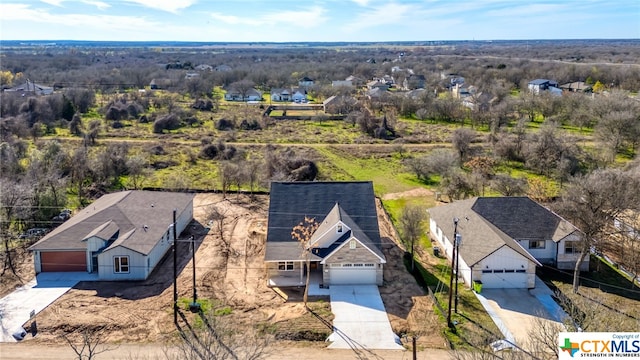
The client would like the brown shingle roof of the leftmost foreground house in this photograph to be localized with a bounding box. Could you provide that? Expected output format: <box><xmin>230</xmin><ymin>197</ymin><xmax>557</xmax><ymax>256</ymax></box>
<box><xmin>29</xmin><ymin>190</ymin><xmax>193</xmax><ymax>254</ymax></box>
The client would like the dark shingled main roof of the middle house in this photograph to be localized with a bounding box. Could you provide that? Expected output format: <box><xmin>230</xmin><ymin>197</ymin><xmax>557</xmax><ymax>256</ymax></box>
<box><xmin>265</xmin><ymin>181</ymin><xmax>384</xmax><ymax>260</ymax></box>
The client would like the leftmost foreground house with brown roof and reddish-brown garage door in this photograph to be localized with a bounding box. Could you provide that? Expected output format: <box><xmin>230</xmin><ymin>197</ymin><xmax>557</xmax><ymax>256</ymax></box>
<box><xmin>29</xmin><ymin>190</ymin><xmax>193</xmax><ymax>280</ymax></box>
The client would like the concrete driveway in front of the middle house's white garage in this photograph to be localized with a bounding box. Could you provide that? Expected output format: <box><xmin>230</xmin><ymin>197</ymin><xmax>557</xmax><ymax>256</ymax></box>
<box><xmin>329</xmin><ymin>285</ymin><xmax>404</xmax><ymax>350</ymax></box>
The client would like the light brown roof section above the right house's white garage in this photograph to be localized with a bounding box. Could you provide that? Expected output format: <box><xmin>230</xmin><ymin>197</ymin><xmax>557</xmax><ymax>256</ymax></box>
<box><xmin>429</xmin><ymin>198</ymin><xmax>540</xmax><ymax>266</ymax></box>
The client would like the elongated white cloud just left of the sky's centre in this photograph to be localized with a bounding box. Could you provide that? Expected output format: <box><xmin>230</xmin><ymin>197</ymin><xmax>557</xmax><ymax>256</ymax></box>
<box><xmin>211</xmin><ymin>6</ymin><xmax>327</xmax><ymax>28</ymax></box>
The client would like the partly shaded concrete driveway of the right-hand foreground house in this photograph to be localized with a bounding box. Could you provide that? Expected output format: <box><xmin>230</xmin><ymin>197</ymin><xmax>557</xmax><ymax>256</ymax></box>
<box><xmin>476</xmin><ymin>278</ymin><xmax>567</xmax><ymax>349</ymax></box>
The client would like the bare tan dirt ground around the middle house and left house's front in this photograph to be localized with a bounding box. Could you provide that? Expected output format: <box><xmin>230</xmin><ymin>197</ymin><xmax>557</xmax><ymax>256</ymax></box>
<box><xmin>1</xmin><ymin>194</ymin><xmax>445</xmax><ymax>348</ymax></box>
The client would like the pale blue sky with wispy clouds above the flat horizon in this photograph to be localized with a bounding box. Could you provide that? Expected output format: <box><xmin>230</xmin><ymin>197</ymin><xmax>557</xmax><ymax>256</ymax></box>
<box><xmin>0</xmin><ymin>0</ymin><xmax>640</xmax><ymax>42</ymax></box>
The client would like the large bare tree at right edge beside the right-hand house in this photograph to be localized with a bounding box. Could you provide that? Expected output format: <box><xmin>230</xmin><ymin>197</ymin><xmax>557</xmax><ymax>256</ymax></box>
<box><xmin>558</xmin><ymin>169</ymin><xmax>640</xmax><ymax>292</ymax></box>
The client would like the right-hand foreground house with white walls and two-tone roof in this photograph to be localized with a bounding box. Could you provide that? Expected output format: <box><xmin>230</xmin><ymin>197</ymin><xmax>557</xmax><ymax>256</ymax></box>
<box><xmin>429</xmin><ymin>197</ymin><xmax>589</xmax><ymax>288</ymax></box>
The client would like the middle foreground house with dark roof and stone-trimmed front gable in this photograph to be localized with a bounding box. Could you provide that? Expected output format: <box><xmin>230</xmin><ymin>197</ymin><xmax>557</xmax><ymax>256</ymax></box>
<box><xmin>264</xmin><ymin>182</ymin><xmax>386</xmax><ymax>287</ymax></box>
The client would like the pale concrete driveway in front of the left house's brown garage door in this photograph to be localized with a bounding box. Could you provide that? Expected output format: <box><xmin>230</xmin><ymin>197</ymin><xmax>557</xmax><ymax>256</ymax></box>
<box><xmin>0</xmin><ymin>273</ymin><xmax>97</xmax><ymax>342</ymax></box>
